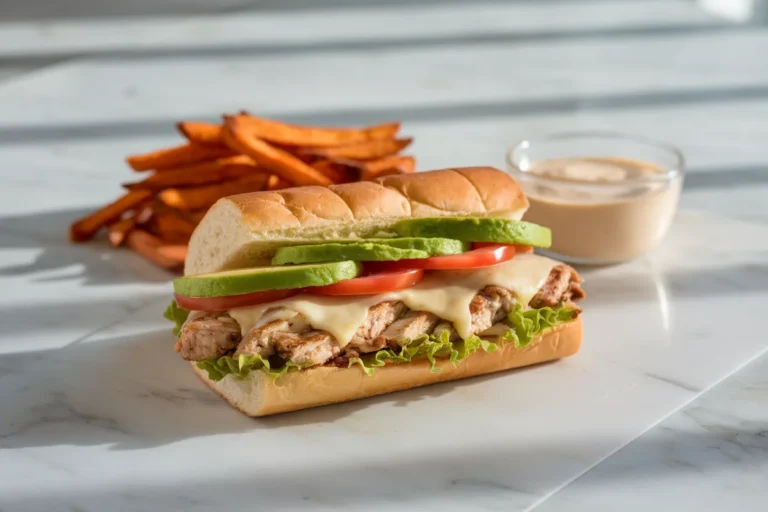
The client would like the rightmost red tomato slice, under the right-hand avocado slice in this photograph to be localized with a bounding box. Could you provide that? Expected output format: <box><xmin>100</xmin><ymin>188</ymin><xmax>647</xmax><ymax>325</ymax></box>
<box><xmin>366</xmin><ymin>243</ymin><xmax>515</xmax><ymax>272</ymax></box>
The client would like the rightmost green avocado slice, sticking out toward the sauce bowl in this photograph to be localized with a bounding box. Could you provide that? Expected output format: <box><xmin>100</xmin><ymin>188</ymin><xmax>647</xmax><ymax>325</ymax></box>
<box><xmin>392</xmin><ymin>217</ymin><xmax>552</xmax><ymax>248</ymax></box>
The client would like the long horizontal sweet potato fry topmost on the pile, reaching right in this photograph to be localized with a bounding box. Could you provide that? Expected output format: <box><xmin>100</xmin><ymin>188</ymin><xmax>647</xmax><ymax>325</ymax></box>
<box><xmin>235</xmin><ymin>112</ymin><xmax>400</xmax><ymax>148</ymax></box>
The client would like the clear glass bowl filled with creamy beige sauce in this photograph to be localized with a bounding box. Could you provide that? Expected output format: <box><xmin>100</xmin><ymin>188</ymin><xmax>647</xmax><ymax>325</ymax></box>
<box><xmin>506</xmin><ymin>132</ymin><xmax>685</xmax><ymax>265</ymax></box>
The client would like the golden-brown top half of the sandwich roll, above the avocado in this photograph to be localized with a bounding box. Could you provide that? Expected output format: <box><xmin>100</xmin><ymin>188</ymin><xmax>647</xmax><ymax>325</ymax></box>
<box><xmin>184</xmin><ymin>167</ymin><xmax>528</xmax><ymax>275</ymax></box>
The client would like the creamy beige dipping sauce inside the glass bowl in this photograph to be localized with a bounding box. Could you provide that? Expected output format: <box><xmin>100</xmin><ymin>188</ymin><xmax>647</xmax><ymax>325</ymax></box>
<box><xmin>521</xmin><ymin>157</ymin><xmax>683</xmax><ymax>263</ymax></box>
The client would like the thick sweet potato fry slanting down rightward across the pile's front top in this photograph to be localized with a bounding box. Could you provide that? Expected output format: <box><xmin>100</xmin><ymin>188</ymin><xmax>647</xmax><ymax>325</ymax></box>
<box><xmin>223</xmin><ymin>117</ymin><xmax>333</xmax><ymax>185</ymax></box>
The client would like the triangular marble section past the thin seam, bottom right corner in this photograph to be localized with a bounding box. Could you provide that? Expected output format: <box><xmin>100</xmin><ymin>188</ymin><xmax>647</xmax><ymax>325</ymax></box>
<box><xmin>536</xmin><ymin>357</ymin><xmax>768</xmax><ymax>512</ymax></box>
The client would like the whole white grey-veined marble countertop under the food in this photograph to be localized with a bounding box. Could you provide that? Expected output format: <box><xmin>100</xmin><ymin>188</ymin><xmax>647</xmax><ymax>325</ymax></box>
<box><xmin>0</xmin><ymin>0</ymin><xmax>768</xmax><ymax>512</ymax></box>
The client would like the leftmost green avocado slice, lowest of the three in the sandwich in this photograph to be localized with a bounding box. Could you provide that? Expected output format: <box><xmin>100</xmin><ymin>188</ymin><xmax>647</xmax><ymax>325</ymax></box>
<box><xmin>173</xmin><ymin>261</ymin><xmax>361</xmax><ymax>297</ymax></box>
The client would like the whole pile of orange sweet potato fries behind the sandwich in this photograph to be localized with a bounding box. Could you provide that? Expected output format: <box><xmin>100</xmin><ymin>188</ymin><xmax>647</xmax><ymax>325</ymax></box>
<box><xmin>70</xmin><ymin>112</ymin><xmax>416</xmax><ymax>270</ymax></box>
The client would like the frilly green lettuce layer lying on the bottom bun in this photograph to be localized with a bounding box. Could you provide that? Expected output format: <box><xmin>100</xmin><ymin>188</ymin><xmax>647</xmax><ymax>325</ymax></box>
<box><xmin>190</xmin><ymin>306</ymin><xmax>576</xmax><ymax>381</ymax></box>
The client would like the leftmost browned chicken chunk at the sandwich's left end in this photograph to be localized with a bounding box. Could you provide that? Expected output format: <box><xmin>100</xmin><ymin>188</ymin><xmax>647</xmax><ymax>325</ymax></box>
<box><xmin>173</xmin><ymin>313</ymin><xmax>242</xmax><ymax>361</ymax></box>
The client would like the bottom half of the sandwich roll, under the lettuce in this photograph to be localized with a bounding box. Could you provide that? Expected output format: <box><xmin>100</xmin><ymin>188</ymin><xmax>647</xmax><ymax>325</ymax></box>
<box><xmin>191</xmin><ymin>317</ymin><xmax>582</xmax><ymax>417</ymax></box>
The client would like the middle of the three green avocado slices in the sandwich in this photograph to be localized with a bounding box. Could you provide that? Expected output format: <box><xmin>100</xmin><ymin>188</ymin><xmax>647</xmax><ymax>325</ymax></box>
<box><xmin>272</xmin><ymin>238</ymin><xmax>469</xmax><ymax>265</ymax></box>
